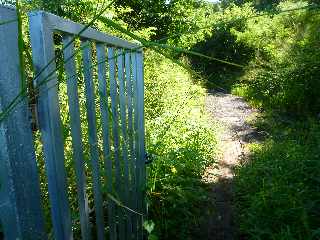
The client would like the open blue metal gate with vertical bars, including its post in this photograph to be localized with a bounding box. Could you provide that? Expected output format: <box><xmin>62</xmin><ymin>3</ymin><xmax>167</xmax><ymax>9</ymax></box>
<box><xmin>0</xmin><ymin>7</ymin><xmax>145</xmax><ymax>240</ymax></box>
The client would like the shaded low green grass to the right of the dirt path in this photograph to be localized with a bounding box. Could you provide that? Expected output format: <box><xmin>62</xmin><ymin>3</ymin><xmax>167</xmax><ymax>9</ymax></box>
<box><xmin>235</xmin><ymin>116</ymin><xmax>320</xmax><ymax>240</ymax></box>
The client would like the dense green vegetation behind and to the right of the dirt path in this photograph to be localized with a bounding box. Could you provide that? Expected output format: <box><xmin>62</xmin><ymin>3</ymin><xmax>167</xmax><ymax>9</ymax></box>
<box><xmin>114</xmin><ymin>0</ymin><xmax>320</xmax><ymax>239</ymax></box>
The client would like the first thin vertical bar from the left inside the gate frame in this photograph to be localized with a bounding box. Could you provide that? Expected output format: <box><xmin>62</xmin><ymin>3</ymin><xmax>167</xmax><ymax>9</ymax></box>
<box><xmin>63</xmin><ymin>35</ymin><xmax>91</xmax><ymax>240</ymax></box>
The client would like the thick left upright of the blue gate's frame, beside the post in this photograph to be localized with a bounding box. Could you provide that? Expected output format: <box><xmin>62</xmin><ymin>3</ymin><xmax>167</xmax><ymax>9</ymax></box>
<box><xmin>29</xmin><ymin>12</ymin><xmax>73</xmax><ymax>240</ymax></box>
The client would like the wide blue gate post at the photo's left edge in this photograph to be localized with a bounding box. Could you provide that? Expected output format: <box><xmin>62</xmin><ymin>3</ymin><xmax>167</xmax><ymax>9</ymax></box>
<box><xmin>0</xmin><ymin>6</ymin><xmax>46</xmax><ymax>240</ymax></box>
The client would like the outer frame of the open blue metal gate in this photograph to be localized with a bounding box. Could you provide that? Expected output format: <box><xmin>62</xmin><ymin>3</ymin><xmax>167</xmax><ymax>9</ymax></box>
<box><xmin>29</xmin><ymin>11</ymin><xmax>145</xmax><ymax>239</ymax></box>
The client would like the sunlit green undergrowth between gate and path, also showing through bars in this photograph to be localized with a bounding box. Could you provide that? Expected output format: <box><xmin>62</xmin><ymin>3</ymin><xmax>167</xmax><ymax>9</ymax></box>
<box><xmin>1</xmin><ymin>2</ymin><xmax>219</xmax><ymax>239</ymax></box>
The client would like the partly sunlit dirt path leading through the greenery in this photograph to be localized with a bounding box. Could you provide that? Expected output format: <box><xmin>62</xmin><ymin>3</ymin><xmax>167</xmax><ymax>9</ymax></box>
<box><xmin>203</xmin><ymin>92</ymin><xmax>259</xmax><ymax>240</ymax></box>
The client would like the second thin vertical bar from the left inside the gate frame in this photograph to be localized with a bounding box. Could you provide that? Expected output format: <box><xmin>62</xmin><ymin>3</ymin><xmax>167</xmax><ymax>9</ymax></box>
<box><xmin>81</xmin><ymin>41</ymin><xmax>105</xmax><ymax>240</ymax></box>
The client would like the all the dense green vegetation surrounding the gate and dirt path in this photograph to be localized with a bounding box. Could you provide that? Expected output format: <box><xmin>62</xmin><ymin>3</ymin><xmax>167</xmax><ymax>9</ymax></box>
<box><xmin>1</xmin><ymin>0</ymin><xmax>320</xmax><ymax>240</ymax></box>
